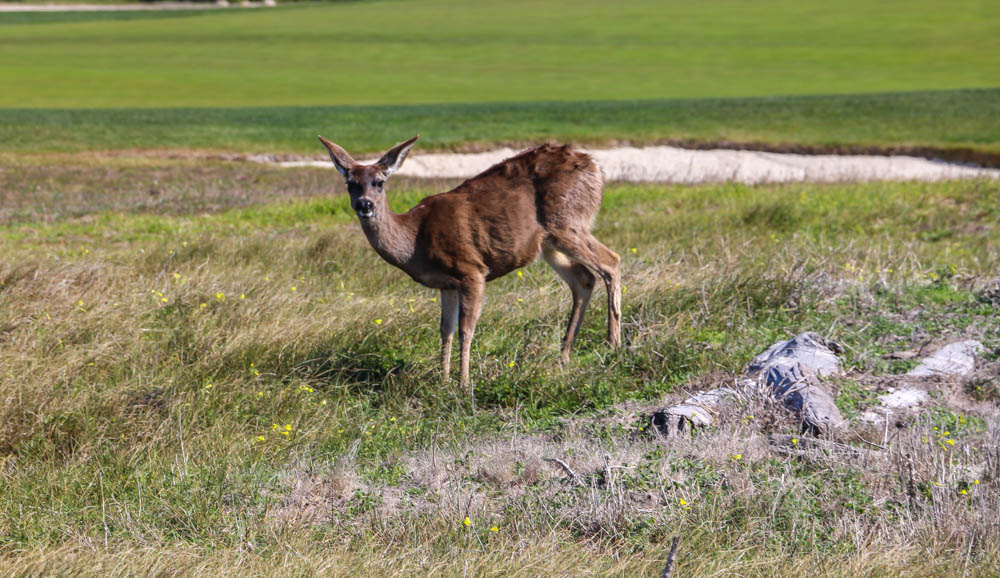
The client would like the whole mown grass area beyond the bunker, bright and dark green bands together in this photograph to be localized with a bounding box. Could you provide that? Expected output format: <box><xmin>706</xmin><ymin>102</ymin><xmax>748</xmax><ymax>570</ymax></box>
<box><xmin>0</xmin><ymin>0</ymin><xmax>1000</xmax><ymax>155</ymax></box>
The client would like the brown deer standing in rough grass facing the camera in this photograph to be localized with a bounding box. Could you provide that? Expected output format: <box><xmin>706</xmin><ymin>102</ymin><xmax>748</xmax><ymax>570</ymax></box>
<box><xmin>319</xmin><ymin>137</ymin><xmax>621</xmax><ymax>392</ymax></box>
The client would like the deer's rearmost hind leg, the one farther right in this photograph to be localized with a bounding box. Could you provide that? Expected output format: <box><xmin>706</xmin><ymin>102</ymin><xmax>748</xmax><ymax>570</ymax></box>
<box><xmin>549</xmin><ymin>229</ymin><xmax>622</xmax><ymax>347</ymax></box>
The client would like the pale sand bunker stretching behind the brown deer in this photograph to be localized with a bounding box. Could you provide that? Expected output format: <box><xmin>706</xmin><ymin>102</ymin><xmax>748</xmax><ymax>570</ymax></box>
<box><xmin>279</xmin><ymin>146</ymin><xmax>1000</xmax><ymax>184</ymax></box>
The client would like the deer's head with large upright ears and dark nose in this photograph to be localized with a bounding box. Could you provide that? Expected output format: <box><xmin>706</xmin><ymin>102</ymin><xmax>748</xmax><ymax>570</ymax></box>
<box><xmin>319</xmin><ymin>136</ymin><xmax>418</xmax><ymax>221</ymax></box>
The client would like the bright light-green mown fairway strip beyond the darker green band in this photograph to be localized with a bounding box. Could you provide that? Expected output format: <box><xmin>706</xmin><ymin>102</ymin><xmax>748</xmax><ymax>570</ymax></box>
<box><xmin>0</xmin><ymin>0</ymin><xmax>1000</xmax><ymax>108</ymax></box>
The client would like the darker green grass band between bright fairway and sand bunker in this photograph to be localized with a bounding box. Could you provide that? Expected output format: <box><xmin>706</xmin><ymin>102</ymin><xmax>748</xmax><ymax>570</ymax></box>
<box><xmin>0</xmin><ymin>89</ymin><xmax>1000</xmax><ymax>155</ymax></box>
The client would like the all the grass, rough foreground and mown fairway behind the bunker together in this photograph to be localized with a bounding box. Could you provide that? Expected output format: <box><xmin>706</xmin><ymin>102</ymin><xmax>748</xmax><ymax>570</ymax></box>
<box><xmin>0</xmin><ymin>0</ymin><xmax>1000</xmax><ymax>576</ymax></box>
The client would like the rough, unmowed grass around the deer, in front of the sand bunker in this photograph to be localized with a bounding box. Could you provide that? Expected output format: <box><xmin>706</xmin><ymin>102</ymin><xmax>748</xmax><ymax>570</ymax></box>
<box><xmin>0</xmin><ymin>162</ymin><xmax>1000</xmax><ymax>575</ymax></box>
